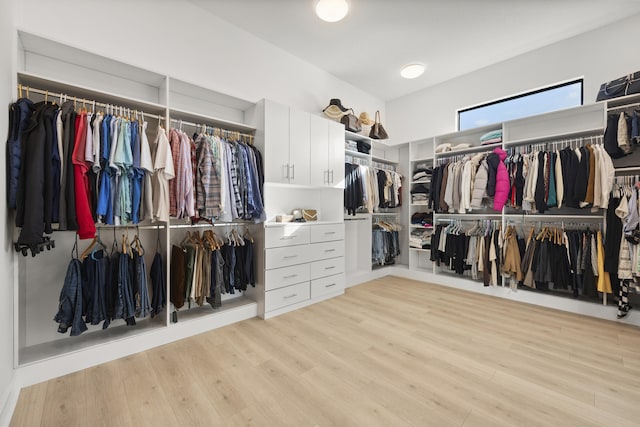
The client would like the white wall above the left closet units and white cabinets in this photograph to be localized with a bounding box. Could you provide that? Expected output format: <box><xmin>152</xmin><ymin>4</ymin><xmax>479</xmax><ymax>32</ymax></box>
<box><xmin>16</xmin><ymin>0</ymin><xmax>384</xmax><ymax>120</ymax></box>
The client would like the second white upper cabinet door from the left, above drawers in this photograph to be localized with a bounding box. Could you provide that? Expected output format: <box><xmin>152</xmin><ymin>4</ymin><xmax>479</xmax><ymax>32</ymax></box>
<box><xmin>289</xmin><ymin>109</ymin><xmax>311</xmax><ymax>185</ymax></box>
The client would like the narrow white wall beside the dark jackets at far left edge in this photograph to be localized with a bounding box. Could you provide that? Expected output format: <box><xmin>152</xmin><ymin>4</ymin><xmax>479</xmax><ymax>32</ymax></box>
<box><xmin>0</xmin><ymin>0</ymin><xmax>15</xmax><ymax>424</ymax></box>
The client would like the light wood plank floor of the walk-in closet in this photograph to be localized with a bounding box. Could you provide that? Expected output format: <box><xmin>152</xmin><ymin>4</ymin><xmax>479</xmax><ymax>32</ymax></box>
<box><xmin>12</xmin><ymin>278</ymin><xmax>640</xmax><ymax>427</ymax></box>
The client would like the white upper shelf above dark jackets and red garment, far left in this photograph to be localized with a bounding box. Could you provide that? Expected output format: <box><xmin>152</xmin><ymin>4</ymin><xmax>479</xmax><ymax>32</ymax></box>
<box><xmin>18</xmin><ymin>72</ymin><xmax>166</xmax><ymax>117</ymax></box>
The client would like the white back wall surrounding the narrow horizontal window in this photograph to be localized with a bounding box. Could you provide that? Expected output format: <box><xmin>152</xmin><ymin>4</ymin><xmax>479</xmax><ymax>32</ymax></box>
<box><xmin>385</xmin><ymin>14</ymin><xmax>640</xmax><ymax>143</ymax></box>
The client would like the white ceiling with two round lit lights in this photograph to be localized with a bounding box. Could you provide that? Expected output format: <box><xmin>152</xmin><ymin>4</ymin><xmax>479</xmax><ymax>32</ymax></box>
<box><xmin>190</xmin><ymin>0</ymin><xmax>640</xmax><ymax>101</ymax></box>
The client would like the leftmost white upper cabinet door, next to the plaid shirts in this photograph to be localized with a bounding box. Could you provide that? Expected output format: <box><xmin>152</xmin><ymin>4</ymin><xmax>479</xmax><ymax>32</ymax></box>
<box><xmin>264</xmin><ymin>101</ymin><xmax>290</xmax><ymax>183</ymax></box>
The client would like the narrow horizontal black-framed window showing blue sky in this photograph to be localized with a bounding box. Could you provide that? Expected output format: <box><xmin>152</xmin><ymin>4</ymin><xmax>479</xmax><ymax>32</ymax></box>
<box><xmin>458</xmin><ymin>79</ymin><xmax>583</xmax><ymax>130</ymax></box>
